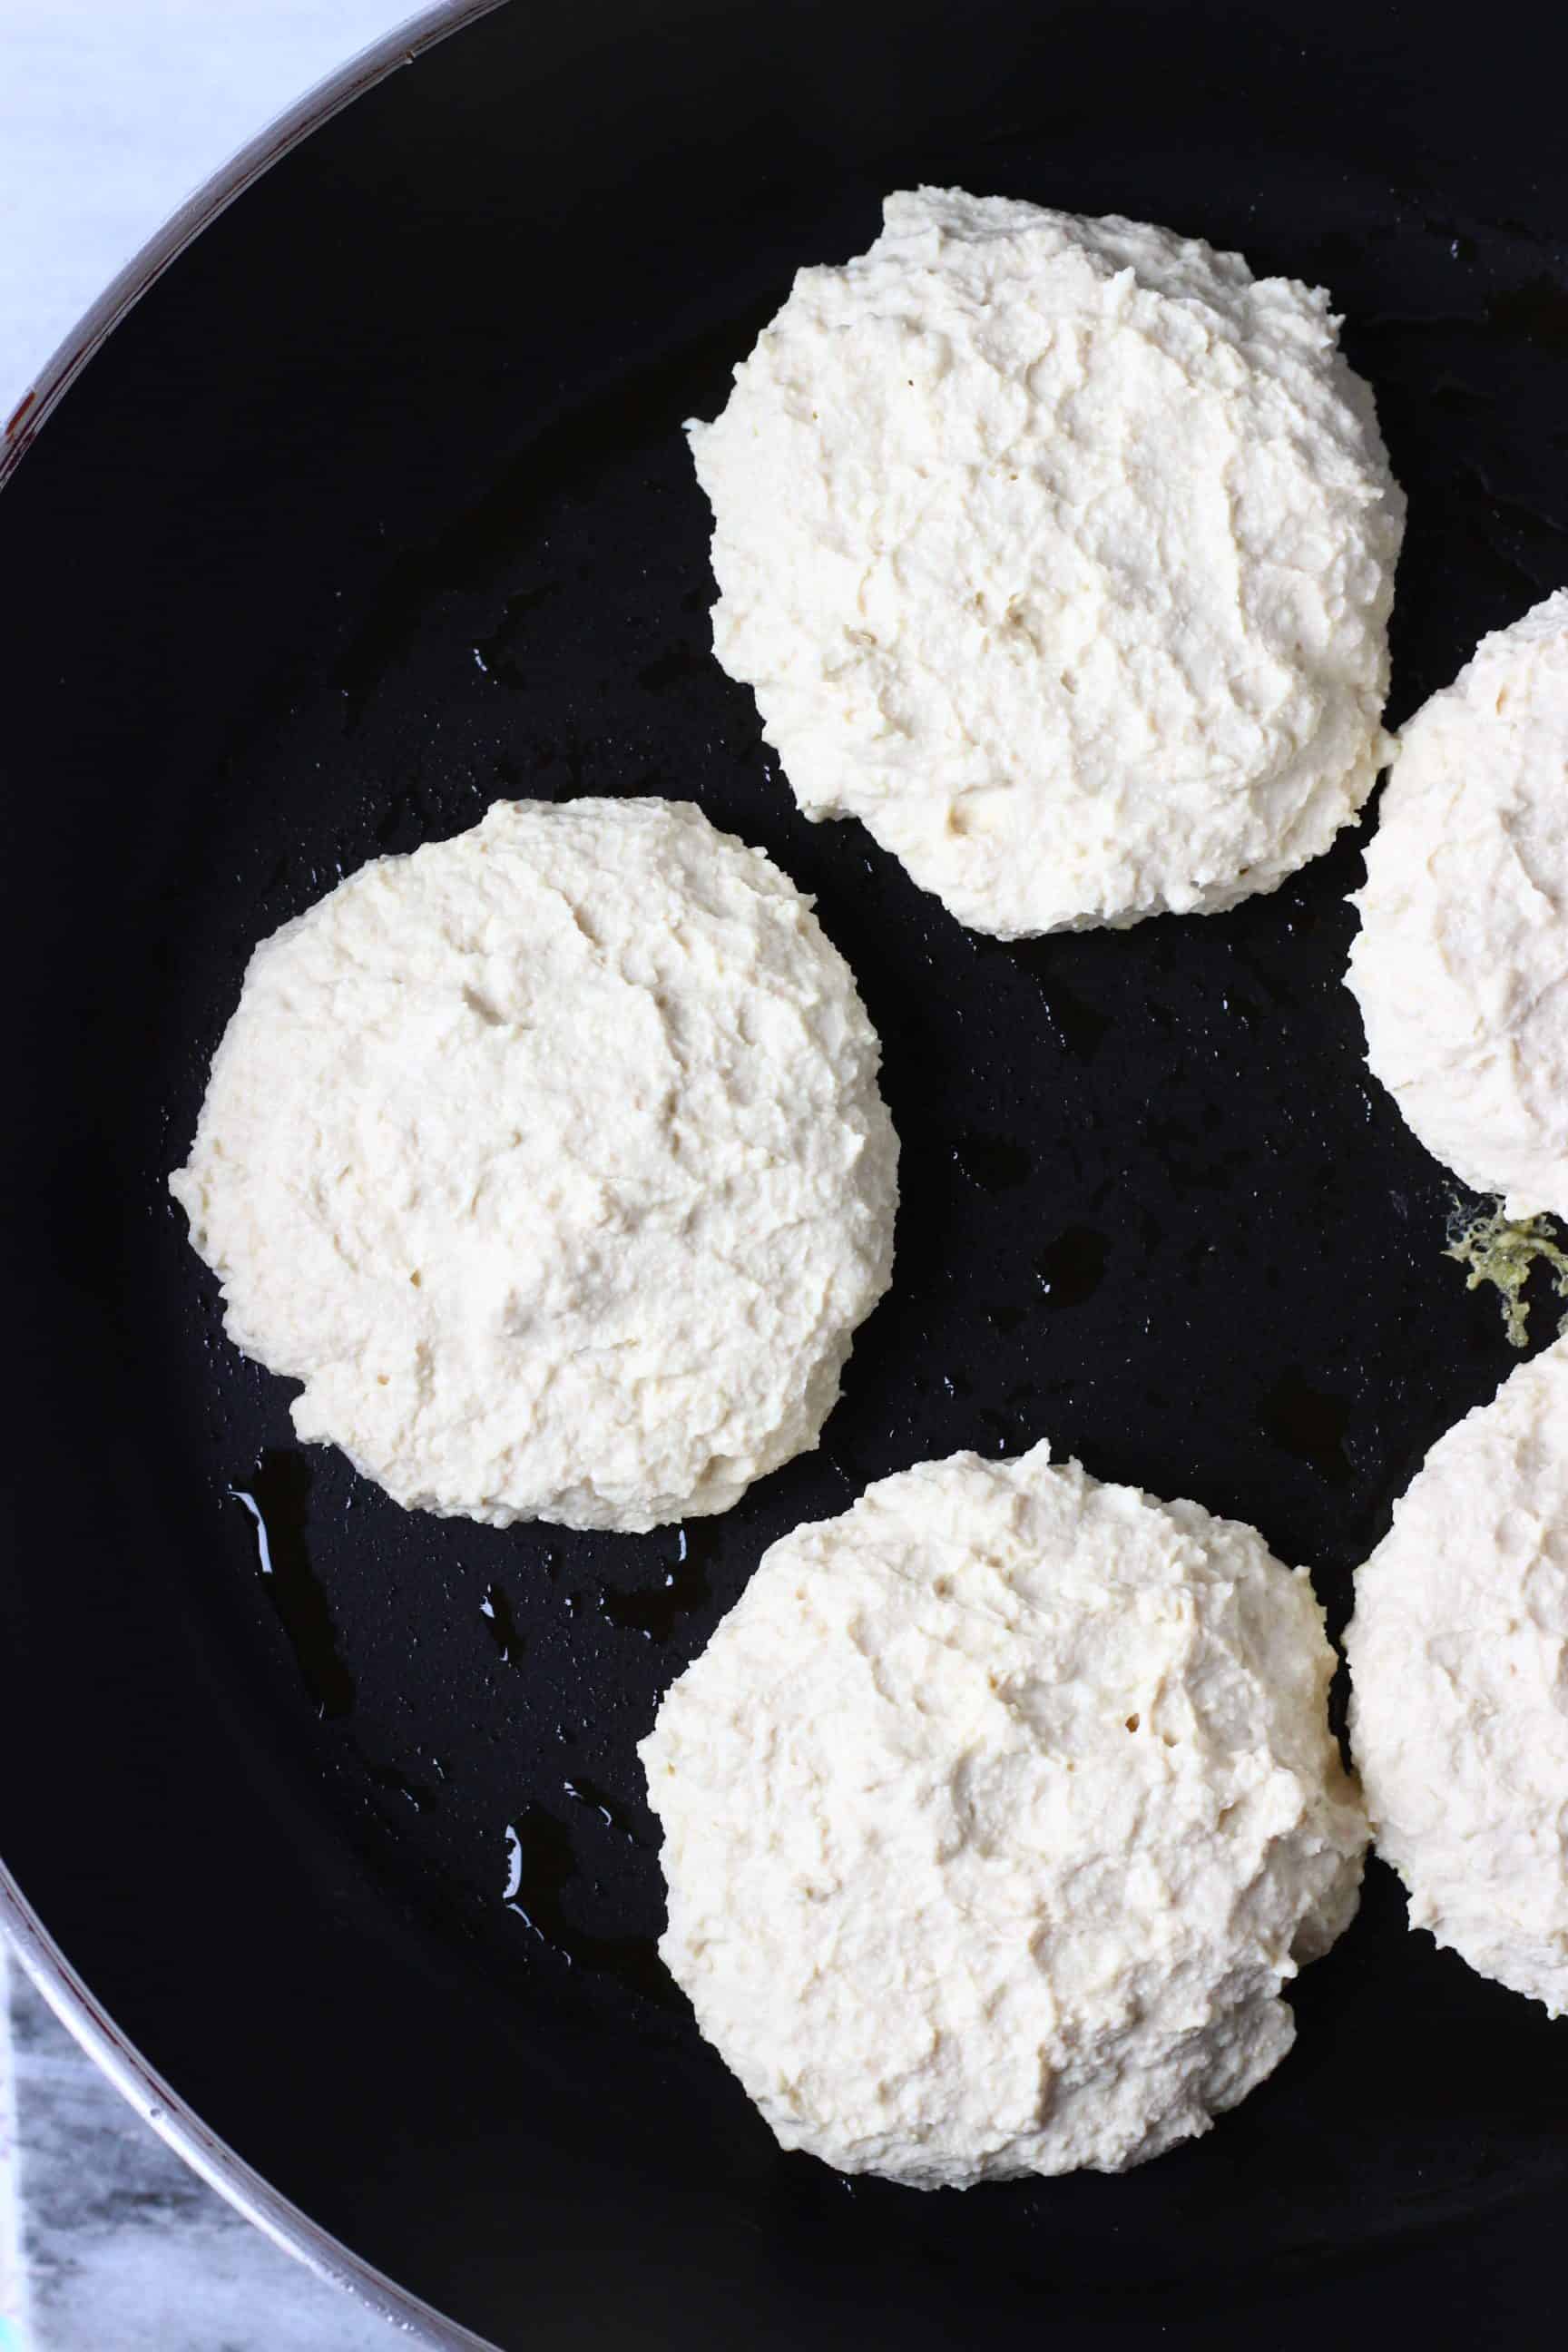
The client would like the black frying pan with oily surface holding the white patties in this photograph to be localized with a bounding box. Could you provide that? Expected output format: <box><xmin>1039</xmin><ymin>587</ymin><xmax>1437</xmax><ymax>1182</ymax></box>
<box><xmin>0</xmin><ymin>0</ymin><xmax>1568</xmax><ymax>2352</ymax></box>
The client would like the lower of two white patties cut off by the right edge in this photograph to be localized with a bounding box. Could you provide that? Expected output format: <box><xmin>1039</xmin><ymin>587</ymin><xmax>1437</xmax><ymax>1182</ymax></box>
<box><xmin>1345</xmin><ymin>1340</ymin><xmax>1568</xmax><ymax>2015</ymax></box>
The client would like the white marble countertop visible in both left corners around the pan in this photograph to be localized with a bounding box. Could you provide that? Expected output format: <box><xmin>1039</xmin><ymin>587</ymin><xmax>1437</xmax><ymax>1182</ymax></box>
<box><xmin>0</xmin><ymin>23</ymin><xmax>472</xmax><ymax>2352</ymax></box>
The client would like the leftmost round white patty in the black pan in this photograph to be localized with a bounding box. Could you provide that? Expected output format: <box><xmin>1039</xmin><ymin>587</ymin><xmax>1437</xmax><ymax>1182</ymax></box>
<box><xmin>172</xmin><ymin>799</ymin><xmax>898</xmax><ymax>1529</ymax></box>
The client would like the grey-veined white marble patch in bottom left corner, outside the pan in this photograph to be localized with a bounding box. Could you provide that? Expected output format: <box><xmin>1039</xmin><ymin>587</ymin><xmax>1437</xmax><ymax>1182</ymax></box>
<box><xmin>0</xmin><ymin>1947</ymin><xmax>409</xmax><ymax>2352</ymax></box>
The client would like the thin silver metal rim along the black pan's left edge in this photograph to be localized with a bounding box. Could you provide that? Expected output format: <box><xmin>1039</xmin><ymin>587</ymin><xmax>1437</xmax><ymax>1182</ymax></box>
<box><xmin>0</xmin><ymin>0</ymin><xmax>503</xmax><ymax>2352</ymax></box>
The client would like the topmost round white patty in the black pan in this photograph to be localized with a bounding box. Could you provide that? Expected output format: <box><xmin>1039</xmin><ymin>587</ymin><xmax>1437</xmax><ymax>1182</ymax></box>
<box><xmin>689</xmin><ymin>188</ymin><xmax>1404</xmax><ymax>938</ymax></box>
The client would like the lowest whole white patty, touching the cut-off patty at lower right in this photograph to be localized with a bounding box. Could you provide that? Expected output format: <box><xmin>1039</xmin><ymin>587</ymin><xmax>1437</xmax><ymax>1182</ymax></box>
<box><xmin>642</xmin><ymin>1444</ymin><xmax>1366</xmax><ymax>2188</ymax></box>
